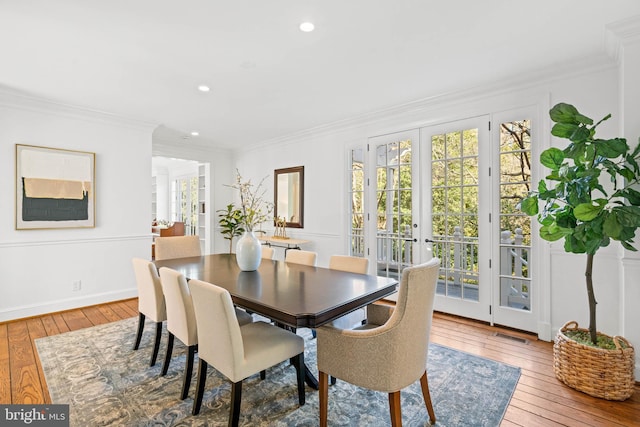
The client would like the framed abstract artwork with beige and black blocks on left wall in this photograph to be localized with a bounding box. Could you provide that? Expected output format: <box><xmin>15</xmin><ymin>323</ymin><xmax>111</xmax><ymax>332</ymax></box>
<box><xmin>16</xmin><ymin>144</ymin><xmax>96</xmax><ymax>230</ymax></box>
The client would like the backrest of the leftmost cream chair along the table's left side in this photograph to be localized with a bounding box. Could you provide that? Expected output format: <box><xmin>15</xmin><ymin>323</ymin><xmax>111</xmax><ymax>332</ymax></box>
<box><xmin>133</xmin><ymin>258</ymin><xmax>167</xmax><ymax>322</ymax></box>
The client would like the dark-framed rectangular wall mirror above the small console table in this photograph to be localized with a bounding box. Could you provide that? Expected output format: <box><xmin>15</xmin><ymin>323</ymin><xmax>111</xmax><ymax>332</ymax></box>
<box><xmin>273</xmin><ymin>166</ymin><xmax>304</xmax><ymax>228</ymax></box>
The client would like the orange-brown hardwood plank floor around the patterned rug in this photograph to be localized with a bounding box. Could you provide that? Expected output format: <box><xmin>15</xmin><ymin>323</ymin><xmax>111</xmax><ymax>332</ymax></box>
<box><xmin>0</xmin><ymin>299</ymin><xmax>640</xmax><ymax>427</ymax></box>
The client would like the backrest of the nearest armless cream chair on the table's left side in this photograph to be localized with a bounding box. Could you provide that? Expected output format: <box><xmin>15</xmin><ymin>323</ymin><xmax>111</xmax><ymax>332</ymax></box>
<box><xmin>189</xmin><ymin>279</ymin><xmax>244</xmax><ymax>378</ymax></box>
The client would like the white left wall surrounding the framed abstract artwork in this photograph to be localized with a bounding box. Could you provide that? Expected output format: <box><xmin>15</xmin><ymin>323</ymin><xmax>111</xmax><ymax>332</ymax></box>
<box><xmin>0</xmin><ymin>92</ymin><xmax>152</xmax><ymax>321</ymax></box>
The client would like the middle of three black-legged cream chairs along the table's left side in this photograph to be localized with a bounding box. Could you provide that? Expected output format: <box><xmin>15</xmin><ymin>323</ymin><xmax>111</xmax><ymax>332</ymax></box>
<box><xmin>160</xmin><ymin>267</ymin><xmax>253</xmax><ymax>400</ymax></box>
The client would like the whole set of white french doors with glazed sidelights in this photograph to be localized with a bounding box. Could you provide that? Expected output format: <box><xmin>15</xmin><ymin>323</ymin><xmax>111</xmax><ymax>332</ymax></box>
<box><xmin>360</xmin><ymin>109</ymin><xmax>540</xmax><ymax>332</ymax></box>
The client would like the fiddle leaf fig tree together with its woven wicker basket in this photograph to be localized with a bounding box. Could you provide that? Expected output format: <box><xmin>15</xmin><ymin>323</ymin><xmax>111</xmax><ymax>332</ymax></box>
<box><xmin>520</xmin><ymin>103</ymin><xmax>640</xmax><ymax>400</ymax></box>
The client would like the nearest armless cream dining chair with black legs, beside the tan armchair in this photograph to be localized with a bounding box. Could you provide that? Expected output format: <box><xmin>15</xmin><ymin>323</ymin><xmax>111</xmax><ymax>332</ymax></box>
<box><xmin>189</xmin><ymin>279</ymin><xmax>305</xmax><ymax>426</ymax></box>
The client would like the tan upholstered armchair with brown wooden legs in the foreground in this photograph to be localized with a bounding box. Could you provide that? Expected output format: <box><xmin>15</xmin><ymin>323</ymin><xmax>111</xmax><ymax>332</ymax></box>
<box><xmin>317</xmin><ymin>258</ymin><xmax>440</xmax><ymax>426</ymax></box>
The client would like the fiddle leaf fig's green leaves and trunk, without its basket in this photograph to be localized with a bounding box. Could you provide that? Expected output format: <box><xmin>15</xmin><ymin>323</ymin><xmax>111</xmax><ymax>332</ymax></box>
<box><xmin>520</xmin><ymin>103</ymin><xmax>640</xmax><ymax>345</ymax></box>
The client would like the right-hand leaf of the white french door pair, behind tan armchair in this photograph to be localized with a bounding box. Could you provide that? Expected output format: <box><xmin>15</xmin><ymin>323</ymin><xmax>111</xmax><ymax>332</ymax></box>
<box><xmin>420</xmin><ymin>116</ymin><xmax>491</xmax><ymax>321</ymax></box>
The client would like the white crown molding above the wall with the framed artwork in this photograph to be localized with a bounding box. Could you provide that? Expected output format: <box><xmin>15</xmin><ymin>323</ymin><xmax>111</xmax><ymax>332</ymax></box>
<box><xmin>0</xmin><ymin>85</ymin><xmax>158</xmax><ymax>132</ymax></box>
